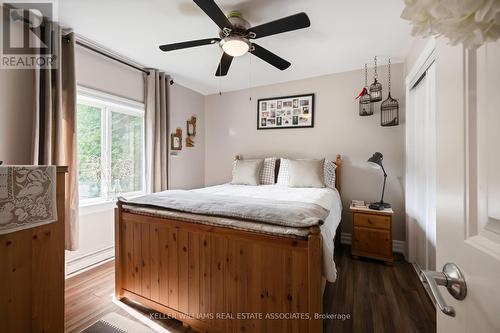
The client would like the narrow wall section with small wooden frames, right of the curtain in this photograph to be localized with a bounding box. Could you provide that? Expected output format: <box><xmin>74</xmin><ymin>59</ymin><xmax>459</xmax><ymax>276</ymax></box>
<box><xmin>168</xmin><ymin>83</ymin><xmax>205</xmax><ymax>189</ymax></box>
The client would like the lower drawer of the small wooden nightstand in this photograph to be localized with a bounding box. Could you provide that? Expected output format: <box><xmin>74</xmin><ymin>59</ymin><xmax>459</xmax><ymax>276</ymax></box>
<box><xmin>352</xmin><ymin>227</ymin><xmax>392</xmax><ymax>258</ymax></box>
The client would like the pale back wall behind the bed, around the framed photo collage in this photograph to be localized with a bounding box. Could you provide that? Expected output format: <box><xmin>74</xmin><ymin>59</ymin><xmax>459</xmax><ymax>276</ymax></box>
<box><xmin>205</xmin><ymin>64</ymin><xmax>405</xmax><ymax>240</ymax></box>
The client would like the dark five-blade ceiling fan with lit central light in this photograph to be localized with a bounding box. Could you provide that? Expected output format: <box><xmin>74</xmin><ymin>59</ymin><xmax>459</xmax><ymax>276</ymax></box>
<box><xmin>160</xmin><ymin>0</ymin><xmax>311</xmax><ymax>76</ymax></box>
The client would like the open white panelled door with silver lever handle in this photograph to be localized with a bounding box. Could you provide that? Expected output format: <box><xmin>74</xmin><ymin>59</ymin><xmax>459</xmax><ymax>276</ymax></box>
<box><xmin>436</xmin><ymin>41</ymin><xmax>500</xmax><ymax>333</ymax></box>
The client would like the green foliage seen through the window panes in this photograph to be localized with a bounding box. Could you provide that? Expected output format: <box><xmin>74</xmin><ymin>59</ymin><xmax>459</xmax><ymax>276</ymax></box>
<box><xmin>77</xmin><ymin>103</ymin><xmax>144</xmax><ymax>199</ymax></box>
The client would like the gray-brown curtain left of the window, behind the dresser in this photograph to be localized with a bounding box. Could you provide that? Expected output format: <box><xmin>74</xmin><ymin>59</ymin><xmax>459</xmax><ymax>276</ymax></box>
<box><xmin>32</xmin><ymin>27</ymin><xmax>78</xmax><ymax>251</ymax></box>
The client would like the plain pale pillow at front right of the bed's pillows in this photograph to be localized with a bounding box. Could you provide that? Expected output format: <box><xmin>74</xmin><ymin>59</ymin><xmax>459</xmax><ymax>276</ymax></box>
<box><xmin>288</xmin><ymin>159</ymin><xmax>325</xmax><ymax>187</ymax></box>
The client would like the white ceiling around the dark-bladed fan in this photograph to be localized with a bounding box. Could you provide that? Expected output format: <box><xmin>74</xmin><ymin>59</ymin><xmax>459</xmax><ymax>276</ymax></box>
<box><xmin>59</xmin><ymin>0</ymin><xmax>411</xmax><ymax>94</ymax></box>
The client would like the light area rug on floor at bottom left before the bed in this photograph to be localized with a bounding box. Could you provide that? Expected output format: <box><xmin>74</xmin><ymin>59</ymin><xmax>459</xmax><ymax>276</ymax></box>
<box><xmin>82</xmin><ymin>312</ymin><xmax>155</xmax><ymax>333</ymax></box>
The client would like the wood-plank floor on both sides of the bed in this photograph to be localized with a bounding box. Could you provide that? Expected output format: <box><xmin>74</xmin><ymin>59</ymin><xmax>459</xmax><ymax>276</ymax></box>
<box><xmin>65</xmin><ymin>246</ymin><xmax>436</xmax><ymax>333</ymax></box>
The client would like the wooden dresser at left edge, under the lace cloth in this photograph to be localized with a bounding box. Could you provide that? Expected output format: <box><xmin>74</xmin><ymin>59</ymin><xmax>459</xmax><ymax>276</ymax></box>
<box><xmin>0</xmin><ymin>167</ymin><xmax>68</xmax><ymax>333</ymax></box>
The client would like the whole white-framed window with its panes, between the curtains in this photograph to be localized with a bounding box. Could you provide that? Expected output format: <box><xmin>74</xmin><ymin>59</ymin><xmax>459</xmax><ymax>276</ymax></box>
<box><xmin>77</xmin><ymin>88</ymin><xmax>145</xmax><ymax>204</ymax></box>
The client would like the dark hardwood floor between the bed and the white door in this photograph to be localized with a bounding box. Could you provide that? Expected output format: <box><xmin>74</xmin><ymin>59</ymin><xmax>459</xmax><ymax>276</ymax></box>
<box><xmin>323</xmin><ymin>246</ymin><xmax>436</xmax><ymax>333</ymax></box>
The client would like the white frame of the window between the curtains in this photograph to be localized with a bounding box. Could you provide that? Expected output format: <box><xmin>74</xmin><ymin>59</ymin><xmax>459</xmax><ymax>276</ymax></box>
<box><xmin>77</xmin><ymin>86</ymin><xmax>146</xmax><ymax>206</ymax></box>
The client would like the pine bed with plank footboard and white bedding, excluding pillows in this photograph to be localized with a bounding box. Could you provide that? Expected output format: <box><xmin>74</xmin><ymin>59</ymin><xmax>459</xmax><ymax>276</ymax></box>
<box><xmin>115</xmin><ymin>156</ymin><xmax>342</xmax><ymax>333</ymax></box>
